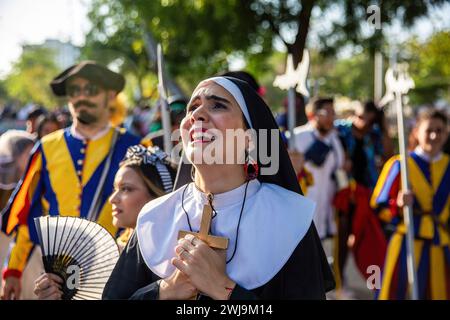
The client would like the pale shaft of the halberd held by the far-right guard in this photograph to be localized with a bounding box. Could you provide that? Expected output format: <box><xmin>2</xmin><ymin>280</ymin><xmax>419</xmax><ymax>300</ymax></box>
<box><xmin>395</xmin><ymin>90</ymin><xmax>419</xmax><ymax>300</ymax></box>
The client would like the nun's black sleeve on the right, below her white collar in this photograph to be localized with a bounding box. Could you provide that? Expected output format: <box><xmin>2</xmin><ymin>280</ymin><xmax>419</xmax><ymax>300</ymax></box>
<box><xmin>230</xmin><ymin>223</ymin><xmax>335</xmax><ymax>300</ymax></box>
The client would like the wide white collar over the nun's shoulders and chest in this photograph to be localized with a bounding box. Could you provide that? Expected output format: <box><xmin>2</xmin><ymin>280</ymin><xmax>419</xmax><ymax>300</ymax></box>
<box><xmin>136</xmin><ymin>180</ymin><xmax>315</xmax><ymax>290</ymax></box>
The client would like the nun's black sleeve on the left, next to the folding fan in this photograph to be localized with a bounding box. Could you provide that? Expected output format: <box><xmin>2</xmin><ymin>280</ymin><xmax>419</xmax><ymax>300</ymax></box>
<box><xmin>102</xmin><ymin>232</ymin><xmax>159</xmax><ymax>300</ymax></box>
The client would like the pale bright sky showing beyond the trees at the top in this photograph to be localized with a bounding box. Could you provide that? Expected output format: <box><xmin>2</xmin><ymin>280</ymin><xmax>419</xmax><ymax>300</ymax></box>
<box><xmin>0</xmin><ymin>0</ymin><xmax>450</xmax><ymax>79</ymax></box>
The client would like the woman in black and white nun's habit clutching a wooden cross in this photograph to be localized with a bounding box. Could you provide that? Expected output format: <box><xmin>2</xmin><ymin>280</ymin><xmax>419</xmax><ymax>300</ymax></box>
<box><xmin>103</xmin><ymin>77</ymin><xmax>334</xmax><ymax>300</ymax></box>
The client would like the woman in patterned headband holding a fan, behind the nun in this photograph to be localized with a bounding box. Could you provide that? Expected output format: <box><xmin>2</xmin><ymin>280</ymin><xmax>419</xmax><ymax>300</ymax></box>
<box><xmin>35</xmin><ymin>145</ymin><xmax>175</xmax><ymax>299</ymax></box>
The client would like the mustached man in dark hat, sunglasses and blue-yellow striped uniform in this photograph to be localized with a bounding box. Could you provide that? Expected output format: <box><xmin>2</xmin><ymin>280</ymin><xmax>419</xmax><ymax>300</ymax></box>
<box><xmin>2</xmin><ymin>61</ymin><xmax>139</xmax><ymax>299</ymax></box>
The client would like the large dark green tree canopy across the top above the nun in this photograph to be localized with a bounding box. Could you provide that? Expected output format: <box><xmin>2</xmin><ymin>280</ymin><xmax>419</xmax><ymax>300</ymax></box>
<box><xmin>83</xmin><ymin>0</ymin><xmax>445</xmax><ymax>100</ymax></box>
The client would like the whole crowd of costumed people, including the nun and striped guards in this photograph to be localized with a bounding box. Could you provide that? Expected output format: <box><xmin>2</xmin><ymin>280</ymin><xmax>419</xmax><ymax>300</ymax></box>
<box><xmin>0</xmin><ymin>61</ymin><xmax>450</xmax><ymax>300</ymax></box>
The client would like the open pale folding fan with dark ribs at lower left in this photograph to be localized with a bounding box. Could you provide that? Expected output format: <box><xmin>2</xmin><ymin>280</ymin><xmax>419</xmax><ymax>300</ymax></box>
<box><xmin>34</xmin><ymin>216</ymin><xmax>119</xmax><ymax>300</ymax></box>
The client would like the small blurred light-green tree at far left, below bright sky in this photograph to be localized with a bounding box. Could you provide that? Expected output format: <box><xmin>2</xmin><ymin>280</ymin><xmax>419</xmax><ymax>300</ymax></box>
<box><xmin>5</xmin><ymin>47</ymin><xmax>59</xmax><ymax>107</ymax></box>
